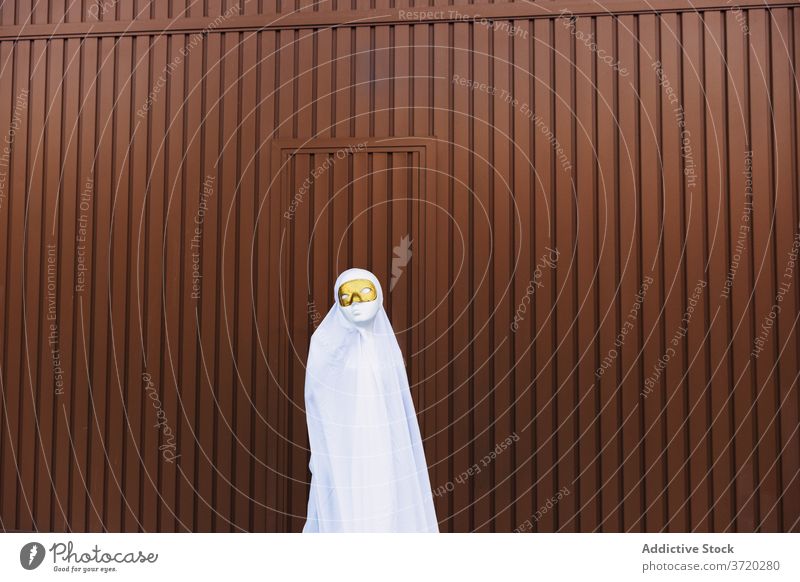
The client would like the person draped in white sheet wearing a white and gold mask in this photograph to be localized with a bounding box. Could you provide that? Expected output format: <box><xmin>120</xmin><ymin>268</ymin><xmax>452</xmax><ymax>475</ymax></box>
<box><xmin>303</xmin><ymin>269</ymin><xmax>439</xmax><ymax>532</ymax></box>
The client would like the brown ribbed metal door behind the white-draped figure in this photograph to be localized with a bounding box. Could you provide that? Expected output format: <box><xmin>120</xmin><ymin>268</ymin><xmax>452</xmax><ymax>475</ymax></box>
<box><xmin>266</xmin><ymin>139</ymin><xmax>435</xmax><ymax>531</ymax></box>
